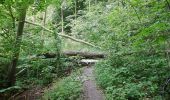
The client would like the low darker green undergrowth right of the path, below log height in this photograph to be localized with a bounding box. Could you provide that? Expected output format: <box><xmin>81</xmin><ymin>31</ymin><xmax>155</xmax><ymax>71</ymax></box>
<box><xmin>95</xmin><ymin>57</ymin><xmax>169</xmax><ymax>100</ymax></box>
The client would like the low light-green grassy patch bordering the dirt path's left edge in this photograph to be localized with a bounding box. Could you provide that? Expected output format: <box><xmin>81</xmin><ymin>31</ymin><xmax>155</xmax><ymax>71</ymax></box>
<box><xmin>43</xmin><ymin>69</ymin><xmax>83</xmax><ymax>100</ymax></box>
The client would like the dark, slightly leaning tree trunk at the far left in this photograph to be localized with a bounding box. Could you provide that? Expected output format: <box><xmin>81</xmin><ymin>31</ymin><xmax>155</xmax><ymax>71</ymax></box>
<box><xmin>8</xmin><ymin>8</ymin><xmax>26</xmax><ymax>86</ymax></box>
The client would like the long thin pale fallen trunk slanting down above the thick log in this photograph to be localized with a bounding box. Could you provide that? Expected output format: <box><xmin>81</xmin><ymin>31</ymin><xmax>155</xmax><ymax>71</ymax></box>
<box><xmin>25</xmin><ymin>21</ymin><xmax>101</xmax><ymax>49</ymax></box>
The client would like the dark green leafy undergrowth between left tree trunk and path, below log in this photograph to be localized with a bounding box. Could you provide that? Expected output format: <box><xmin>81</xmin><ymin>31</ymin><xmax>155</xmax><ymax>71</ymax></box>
<box><xmin>17</xmin><ymin>57</ymin><xmax>80</xmax><ymax>86</ymax></box>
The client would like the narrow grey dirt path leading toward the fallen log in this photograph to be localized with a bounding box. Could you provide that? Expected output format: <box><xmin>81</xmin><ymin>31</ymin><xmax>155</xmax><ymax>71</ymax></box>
<box><xmin>83</xmin><ymin>67</ymin><xmax>104</xmax><ymax>100</ymax></box>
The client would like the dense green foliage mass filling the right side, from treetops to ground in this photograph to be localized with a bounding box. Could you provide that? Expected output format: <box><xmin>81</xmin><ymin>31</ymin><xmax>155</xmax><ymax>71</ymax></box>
<box><xmin>68</xmin><ymin>0</ymin><xmax>170</xmax><ymax>100</ymax></box>
